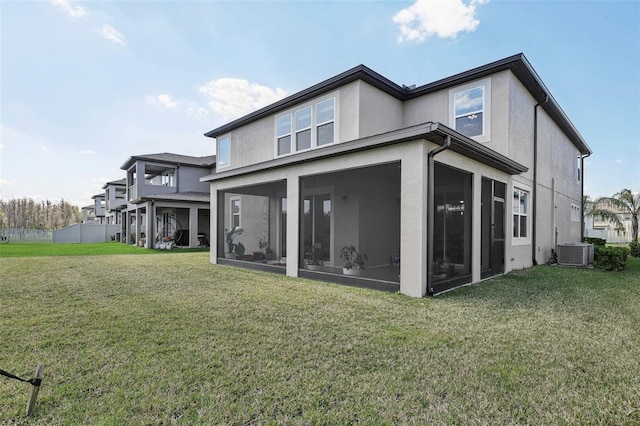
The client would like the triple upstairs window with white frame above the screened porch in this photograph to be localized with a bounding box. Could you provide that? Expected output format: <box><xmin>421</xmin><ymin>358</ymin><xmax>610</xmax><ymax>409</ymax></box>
<box><xmin>276</xmin><ymin>98</ymin><xmax>336</xmax><ymax>156</ymax></box>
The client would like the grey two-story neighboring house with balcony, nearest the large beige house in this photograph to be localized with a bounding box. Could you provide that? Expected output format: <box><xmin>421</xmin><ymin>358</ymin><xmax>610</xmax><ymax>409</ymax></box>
<box><xmin>120</xmin><ymin>153</ymin><xmax>216</xmax><ymax>248</ymax></box>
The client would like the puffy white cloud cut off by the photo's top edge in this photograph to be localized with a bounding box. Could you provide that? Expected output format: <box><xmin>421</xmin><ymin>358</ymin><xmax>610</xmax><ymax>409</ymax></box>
<box><xmin>393</xmin><ymin>0</ymin><xmax>488</xmax><ymax>43</ymax></box>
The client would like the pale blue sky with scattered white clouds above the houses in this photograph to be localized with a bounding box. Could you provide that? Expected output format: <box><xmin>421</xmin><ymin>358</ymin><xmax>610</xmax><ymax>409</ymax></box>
<box><xmin>0</xmin><ymin>0</ymin><xmax>640</xmax><ymax>206</ymax></box>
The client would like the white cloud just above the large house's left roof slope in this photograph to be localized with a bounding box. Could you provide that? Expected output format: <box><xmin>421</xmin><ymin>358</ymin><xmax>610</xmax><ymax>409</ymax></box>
<box><xmin>200</xmin><ymin>78</ymin><xmax>287</xmax><ymax>121</ymax></box>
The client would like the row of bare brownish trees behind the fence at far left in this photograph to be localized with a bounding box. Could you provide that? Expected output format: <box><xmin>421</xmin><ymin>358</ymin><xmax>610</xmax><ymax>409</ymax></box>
<box><xmin>0</xmin><ymin>198</ymin><xmax>82</xmax><ymax>229</ymax></box>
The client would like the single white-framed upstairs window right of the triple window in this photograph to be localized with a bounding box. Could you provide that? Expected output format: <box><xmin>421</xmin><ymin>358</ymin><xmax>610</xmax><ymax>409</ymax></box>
<box><xmin>449</xmin><ymin>78</ymin><xmax>491</xmax><ymax>142</ymax></box>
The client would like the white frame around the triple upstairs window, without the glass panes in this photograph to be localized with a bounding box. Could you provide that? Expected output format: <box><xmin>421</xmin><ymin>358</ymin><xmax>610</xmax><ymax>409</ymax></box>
<box><xmin>273</xmin><ymin>92</ymin><xmax>339</xmax><ymax>158</ymax></box>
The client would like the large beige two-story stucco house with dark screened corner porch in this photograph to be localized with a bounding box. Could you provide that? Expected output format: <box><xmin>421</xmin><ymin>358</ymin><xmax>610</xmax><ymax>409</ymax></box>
<box><xmin>202</xmin><ymin>54</ymin><xmax>591</xmax><ymax>297</ymax></box>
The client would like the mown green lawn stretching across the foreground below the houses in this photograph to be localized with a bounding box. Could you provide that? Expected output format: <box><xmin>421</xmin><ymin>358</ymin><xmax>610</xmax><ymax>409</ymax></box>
<box><xmin>0</xmin><ymin>248</ymin><xmax>640</xmax><ymax>425</ymax></box>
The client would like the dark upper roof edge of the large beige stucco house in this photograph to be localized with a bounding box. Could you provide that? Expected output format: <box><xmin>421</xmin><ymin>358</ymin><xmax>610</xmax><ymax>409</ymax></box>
<box><xmin>205</xmin><ymin>53</ymin><xmax>592</xmax><ymax>154</ymax></box>
